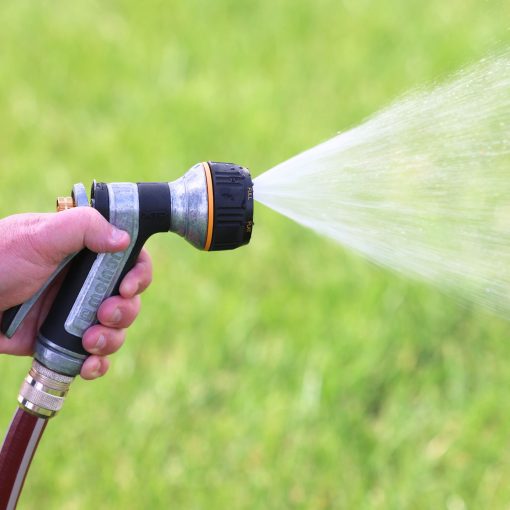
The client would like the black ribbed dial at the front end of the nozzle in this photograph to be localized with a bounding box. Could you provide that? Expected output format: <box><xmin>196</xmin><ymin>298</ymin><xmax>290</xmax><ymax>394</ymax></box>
<box><xmin>209</xmin><ymin>161</ymin><xmax>253</xmax><ymax>251</ymax></box>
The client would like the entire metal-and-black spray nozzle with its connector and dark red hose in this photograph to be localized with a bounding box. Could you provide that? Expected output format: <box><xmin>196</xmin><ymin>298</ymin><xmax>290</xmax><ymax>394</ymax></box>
<box><xmin>0</xmin><ymin>162</ymin><xmax>253</xmax><ymax>510</ymax></box>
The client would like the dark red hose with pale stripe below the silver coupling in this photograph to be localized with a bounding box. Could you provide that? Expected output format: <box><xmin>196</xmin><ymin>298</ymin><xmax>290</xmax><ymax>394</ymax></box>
<box><xmin>0</xmin><ymin>409</ymin><xmax>47</xmax><ymax>510</ymax></box>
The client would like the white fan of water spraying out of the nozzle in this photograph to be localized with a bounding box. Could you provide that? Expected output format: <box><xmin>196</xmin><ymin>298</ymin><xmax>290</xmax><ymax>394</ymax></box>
<box><xmin>254</xmin><ymin>53</ymin><xmax>510</xmax><ymax>318</ymax></box>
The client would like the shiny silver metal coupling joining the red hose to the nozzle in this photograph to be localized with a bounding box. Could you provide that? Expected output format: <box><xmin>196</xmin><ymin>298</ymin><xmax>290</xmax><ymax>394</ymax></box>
<box><xmin>18</xmin><ymin>359</ymin><xmax>74</xmax><ymax>418</ymax></box>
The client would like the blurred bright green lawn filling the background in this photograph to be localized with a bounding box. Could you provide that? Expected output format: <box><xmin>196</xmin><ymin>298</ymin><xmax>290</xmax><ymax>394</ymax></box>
<box><xmin>0</xmin><ymin>0</ymin><xmax>510</xmax><ymax>510</ymax></box>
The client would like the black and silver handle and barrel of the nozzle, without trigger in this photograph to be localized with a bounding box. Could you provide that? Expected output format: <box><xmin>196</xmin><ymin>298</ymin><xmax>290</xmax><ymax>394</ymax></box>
<box><xmin>35</xmin><ymin>183</ymin><xmax>170</xmax><ymax>376</ymax></box>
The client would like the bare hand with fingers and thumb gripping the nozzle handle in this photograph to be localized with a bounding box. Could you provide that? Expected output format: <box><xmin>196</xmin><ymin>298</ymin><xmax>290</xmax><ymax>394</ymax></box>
<box><xmin>0</xmin><ymin>207</ymin><xmax>152</xmax><ymax>379</ymax></box>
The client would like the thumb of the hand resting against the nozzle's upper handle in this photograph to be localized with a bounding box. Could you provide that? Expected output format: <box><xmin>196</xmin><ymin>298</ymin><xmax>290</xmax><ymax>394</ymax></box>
<box><xmin>31</xmin><ymin>207</ymin><xmax>129</xmax><ymax>262</ymax></box>
